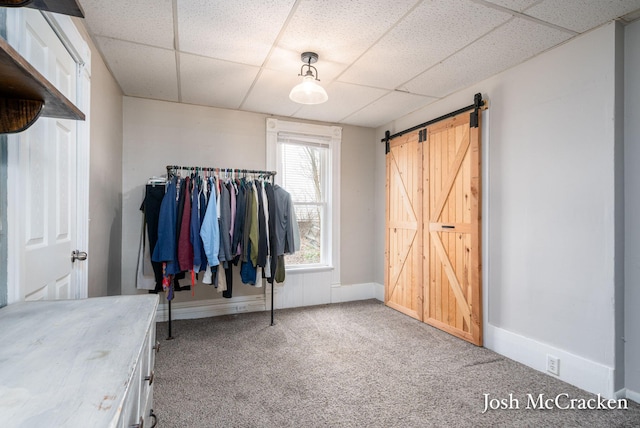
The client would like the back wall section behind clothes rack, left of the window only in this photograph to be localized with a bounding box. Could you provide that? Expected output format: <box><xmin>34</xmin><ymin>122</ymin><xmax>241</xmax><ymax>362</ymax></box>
<box><xmin>122</xmin><ymin>97</ymin><xmax>266</xmax><ymax>302</ymax></box>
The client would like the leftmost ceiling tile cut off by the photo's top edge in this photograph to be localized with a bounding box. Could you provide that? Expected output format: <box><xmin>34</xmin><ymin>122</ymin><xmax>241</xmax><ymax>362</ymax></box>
<box><xmin>80</xmin><ymin>0</ymin><xmax>173</xmax><ymax>49</ymax></box>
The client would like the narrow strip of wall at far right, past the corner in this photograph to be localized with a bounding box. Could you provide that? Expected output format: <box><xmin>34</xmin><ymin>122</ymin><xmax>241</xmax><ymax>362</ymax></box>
<box><xmin>624</xmin><ymin>21</ymin><xmax>640</xmax><ymax>402</ymax></box>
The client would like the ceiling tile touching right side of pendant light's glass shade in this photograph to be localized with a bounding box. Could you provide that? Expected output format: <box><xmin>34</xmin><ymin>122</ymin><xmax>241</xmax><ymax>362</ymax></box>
<box><xmin>294</xmin><ymin>82</ymin><xmax>388</xmax><ymax>122</ymax></box>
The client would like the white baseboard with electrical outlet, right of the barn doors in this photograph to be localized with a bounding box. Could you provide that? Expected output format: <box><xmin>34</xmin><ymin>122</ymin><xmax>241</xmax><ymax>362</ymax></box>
<box><xmin>484</xmin><ymin>325</ymin><xmax>616</xmax><ymax>401</ymax></box>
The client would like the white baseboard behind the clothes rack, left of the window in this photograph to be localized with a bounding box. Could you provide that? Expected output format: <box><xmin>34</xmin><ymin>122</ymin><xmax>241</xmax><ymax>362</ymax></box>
<box><xmin>156</xmin><ymin>293</ymin><xmax>266</xmax><ymax>322</ymax></box>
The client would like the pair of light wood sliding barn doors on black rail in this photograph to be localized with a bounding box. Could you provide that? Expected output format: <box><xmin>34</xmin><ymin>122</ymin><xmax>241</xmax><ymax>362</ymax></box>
<box><xmin>385</xmin><ymin>108</ymin><xmax>482</xmax><ymax>345</ymax></box>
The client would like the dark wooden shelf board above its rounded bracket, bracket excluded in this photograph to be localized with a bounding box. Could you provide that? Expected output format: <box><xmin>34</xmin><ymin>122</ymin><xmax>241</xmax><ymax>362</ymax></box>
<box><xmin>0</xmin><ymin>37</ymin><xmax>85</xmax><ymax>132</ymax></box>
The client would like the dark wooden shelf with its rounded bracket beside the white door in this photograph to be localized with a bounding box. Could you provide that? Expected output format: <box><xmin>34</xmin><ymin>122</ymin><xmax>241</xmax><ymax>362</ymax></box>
<box><xmin>0</xmin><ymin>38</ymin><xmax>85</xmax><ymax>133</ymax></box>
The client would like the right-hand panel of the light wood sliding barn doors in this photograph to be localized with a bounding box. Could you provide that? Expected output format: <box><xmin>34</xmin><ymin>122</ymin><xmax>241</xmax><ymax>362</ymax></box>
<box><xmin>423</xmin><ymin>112</ymin><xmax>482</xmax><ymax>345</ymax></box>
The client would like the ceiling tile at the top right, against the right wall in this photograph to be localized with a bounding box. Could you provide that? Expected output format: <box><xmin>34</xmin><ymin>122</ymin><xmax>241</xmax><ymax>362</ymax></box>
<box><xmin>525</xmin><ymin>0</ymin><xmax>640</xmax><ymax>33</ymax></box>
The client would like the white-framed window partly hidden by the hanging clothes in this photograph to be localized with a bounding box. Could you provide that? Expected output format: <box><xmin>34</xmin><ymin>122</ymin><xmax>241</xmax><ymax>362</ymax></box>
<box><xmin>267</xmin><ymin>119</ymin><xmax>342</xmax><ymax>269</ymax></box>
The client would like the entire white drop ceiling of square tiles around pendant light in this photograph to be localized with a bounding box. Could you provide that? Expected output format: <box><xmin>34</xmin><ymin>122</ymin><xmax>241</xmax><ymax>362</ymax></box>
<box><xmin>79</xmin><ymin>0</ymin><xmax>640</xmax><ymax>127</ymax></box>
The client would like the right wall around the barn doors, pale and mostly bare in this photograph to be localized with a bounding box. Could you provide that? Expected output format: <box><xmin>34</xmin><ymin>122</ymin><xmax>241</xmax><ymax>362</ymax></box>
<box><xmin>376</xmin><ymin>24</ymin><xmax>620</xmax><ymax>396</ymax></box>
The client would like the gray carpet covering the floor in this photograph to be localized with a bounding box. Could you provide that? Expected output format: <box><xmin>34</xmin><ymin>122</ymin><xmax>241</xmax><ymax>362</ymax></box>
<box><xmin>154</xmin><ymin>300</ymin><xmax>640</xmax><ymax>427</ymax></box>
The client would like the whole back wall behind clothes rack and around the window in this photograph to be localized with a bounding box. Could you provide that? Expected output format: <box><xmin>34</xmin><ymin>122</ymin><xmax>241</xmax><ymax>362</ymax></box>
<box><xmin>122</xmin><ymin>97</ymin><xmax>375</xmax><ymax>310</ymax></box>
